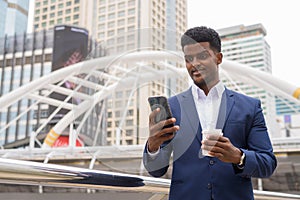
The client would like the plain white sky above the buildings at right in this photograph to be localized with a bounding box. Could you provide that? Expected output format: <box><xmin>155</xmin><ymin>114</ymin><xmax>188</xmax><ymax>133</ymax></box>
<box><xmin>187</xmin><ymin>0</ymin><xmax>300</xmax><ymax>87</ymax></box>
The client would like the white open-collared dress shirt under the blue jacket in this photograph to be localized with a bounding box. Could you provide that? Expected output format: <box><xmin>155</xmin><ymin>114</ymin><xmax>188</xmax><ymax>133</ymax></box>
<box><xmin>192</xmin><ymin>81</ymin><xmax>225</xmax><ymax>130</ymax></box>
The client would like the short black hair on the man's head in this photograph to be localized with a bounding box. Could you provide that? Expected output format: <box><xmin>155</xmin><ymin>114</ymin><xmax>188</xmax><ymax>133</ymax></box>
<box><xmin>181</xmin><ymin>26</ymin><xmax>221</xmax><ymax>52</ymax></box>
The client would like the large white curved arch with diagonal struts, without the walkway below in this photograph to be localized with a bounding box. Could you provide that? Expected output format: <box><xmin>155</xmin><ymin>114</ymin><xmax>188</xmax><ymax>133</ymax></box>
<box><xmin>0</xmin><ymin>50</ymin><xmax>300</xmax><ymax>148</ymax></box>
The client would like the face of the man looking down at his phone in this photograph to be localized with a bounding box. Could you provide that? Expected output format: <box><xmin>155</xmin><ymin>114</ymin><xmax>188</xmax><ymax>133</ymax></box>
<box><xmin>183</xmin><ymin>42</ymin><xmax>222</xmax><ymax>89</ymax></box>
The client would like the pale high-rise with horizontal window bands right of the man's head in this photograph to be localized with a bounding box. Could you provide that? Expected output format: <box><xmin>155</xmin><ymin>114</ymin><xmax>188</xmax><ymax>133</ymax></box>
<box><xmin>218</xmin><ymin>24</ymin><xmax>279</xmax><ymax>135</ymax></box>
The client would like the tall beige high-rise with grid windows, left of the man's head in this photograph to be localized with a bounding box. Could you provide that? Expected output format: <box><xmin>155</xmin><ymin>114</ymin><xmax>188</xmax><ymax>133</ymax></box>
<box><xmin>34</xmin><ymin>0</ymin><xmax>187</xmax><ymax>144</ymax></box>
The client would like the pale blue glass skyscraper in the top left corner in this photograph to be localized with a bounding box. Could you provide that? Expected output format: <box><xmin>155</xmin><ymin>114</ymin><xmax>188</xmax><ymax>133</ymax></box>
<box><xmin>0</xmin><ymin>0</ymin><xmax>29</xmax><ymax>37</ymax></box>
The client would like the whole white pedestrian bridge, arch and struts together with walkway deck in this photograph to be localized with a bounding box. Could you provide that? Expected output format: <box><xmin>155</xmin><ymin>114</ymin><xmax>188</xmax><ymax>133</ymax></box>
<box><xmin>0</xmin><ymin>50</ymin><xmax>300</xmax><ymax>199</ymax></box>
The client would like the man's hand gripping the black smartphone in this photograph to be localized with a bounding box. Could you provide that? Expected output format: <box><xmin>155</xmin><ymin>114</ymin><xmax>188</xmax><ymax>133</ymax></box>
<box><xmin>148</xmin><ymin>108</ymin><xmax>179</xmax><ymax>152</ymax></box>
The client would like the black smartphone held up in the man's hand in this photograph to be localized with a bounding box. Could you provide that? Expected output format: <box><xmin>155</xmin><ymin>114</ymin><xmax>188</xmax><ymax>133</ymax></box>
<box><xmin>148</xmin><ymin>96</ymin><xmax>174</xmax><ymax>134</ymax></box>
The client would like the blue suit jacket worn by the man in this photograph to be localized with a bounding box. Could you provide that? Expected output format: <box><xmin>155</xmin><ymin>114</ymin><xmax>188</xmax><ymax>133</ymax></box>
<box><xmin>143</xmin><ymin>89</ymin><xmax>277</xmax><ymax>200</ymax></box>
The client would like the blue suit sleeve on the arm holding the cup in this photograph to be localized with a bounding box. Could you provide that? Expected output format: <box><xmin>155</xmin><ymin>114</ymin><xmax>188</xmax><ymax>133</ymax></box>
<box><xmin>238</xmin><ymin>100</ymin><xmax>277</xmax><ymax>178</ymax></box>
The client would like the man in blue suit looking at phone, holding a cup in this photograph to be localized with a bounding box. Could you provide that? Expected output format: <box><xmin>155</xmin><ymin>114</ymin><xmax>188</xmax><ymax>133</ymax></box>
<box><xmin>143</xmin><ymin>27</ymin><xmax>277</xmax><ymax>200</ymax></box>
